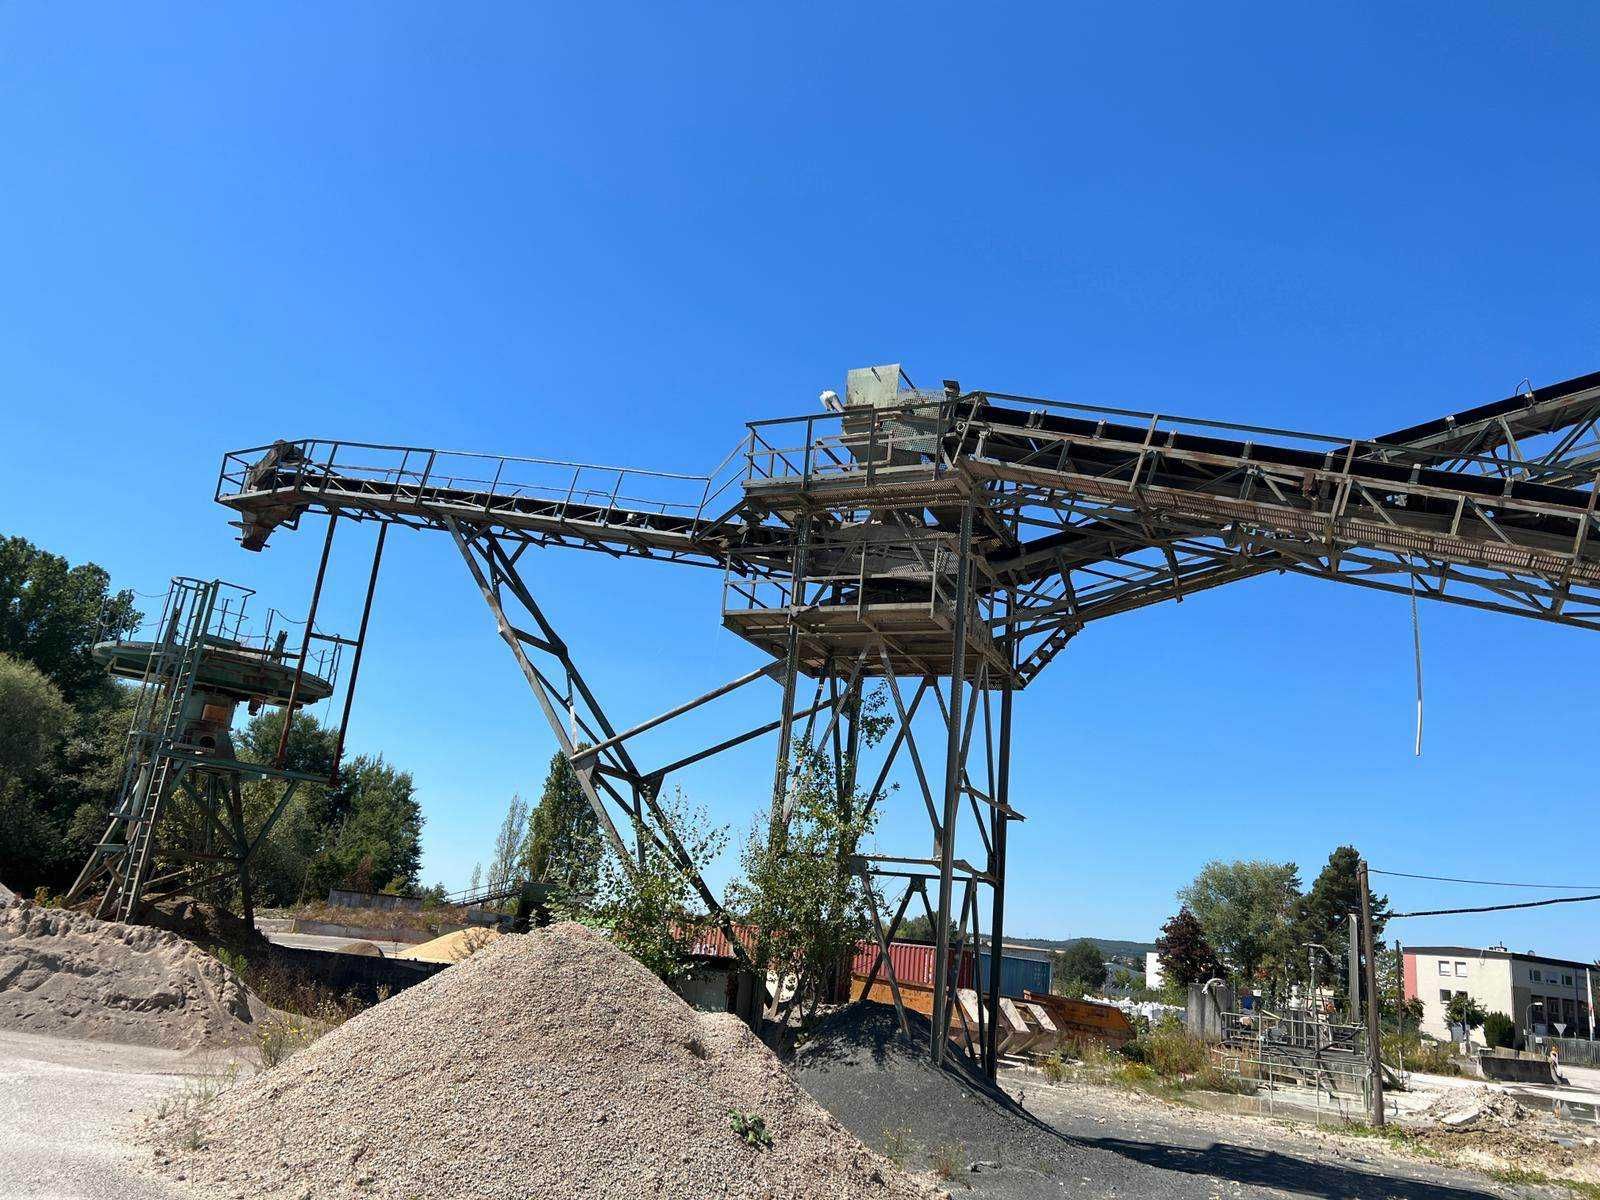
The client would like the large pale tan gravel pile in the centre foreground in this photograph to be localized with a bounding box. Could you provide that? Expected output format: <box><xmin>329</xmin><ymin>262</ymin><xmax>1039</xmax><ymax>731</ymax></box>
<box><xmin>157</xmin><ymin>925</ymin><xmax>936</xmax><ymax>1200</ymax></box>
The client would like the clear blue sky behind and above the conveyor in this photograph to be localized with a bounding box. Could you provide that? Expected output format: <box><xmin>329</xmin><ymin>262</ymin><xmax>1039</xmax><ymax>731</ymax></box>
<box><xmin>0</xmin><ymin>3</ymin><xmax>1600</xmax><ymax>958</ymax></box>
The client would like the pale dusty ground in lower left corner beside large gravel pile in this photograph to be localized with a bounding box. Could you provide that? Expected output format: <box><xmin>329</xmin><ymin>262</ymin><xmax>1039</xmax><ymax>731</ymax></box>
<box><xmin>0</xmin><ymin>1030</ymin><xmax>219</xmax><ymax>1200</ymax></box>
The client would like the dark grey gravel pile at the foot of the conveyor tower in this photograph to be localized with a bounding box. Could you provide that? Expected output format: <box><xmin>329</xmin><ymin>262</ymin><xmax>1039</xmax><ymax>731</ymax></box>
<box><xmin>790</xmin><ymin>1003</ymin><xmax>1102</xmax><ymax>1198</ymax></box>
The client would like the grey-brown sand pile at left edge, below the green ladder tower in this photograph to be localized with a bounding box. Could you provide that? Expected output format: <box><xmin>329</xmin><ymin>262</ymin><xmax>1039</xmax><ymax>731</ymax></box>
<box><xmin>0</xmin><ymin>902</ymin><xmax>267</xmax><ymax>1050</ymax></box>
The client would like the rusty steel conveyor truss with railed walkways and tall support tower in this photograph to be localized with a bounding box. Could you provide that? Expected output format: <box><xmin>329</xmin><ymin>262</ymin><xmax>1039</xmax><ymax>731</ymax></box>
<box><xmin>218</xmin><ymin>366</ymin><xmax>1600</xmax><ymax>1070</ymax></box>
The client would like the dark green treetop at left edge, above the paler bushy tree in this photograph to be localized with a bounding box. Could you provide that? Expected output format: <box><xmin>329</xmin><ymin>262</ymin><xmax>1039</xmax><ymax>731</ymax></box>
<box><xmin>0</xmin><ymin>538</ymin><xmax>141</xmax><ymax>707</ymax></box>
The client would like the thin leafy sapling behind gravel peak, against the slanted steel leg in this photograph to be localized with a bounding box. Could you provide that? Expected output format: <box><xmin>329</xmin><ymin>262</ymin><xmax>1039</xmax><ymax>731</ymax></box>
<box><xmin>588</xmin><ymin>790</ymin><xmax>728</xmax><ymax>982</ymax></box>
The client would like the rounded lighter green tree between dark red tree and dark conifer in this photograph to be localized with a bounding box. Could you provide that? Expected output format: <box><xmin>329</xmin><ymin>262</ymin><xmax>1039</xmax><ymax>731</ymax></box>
<box><xmin>1178</xmin><ymin>861</ymin><xmax>1299</xmax><ymax>984</ymax></box>
